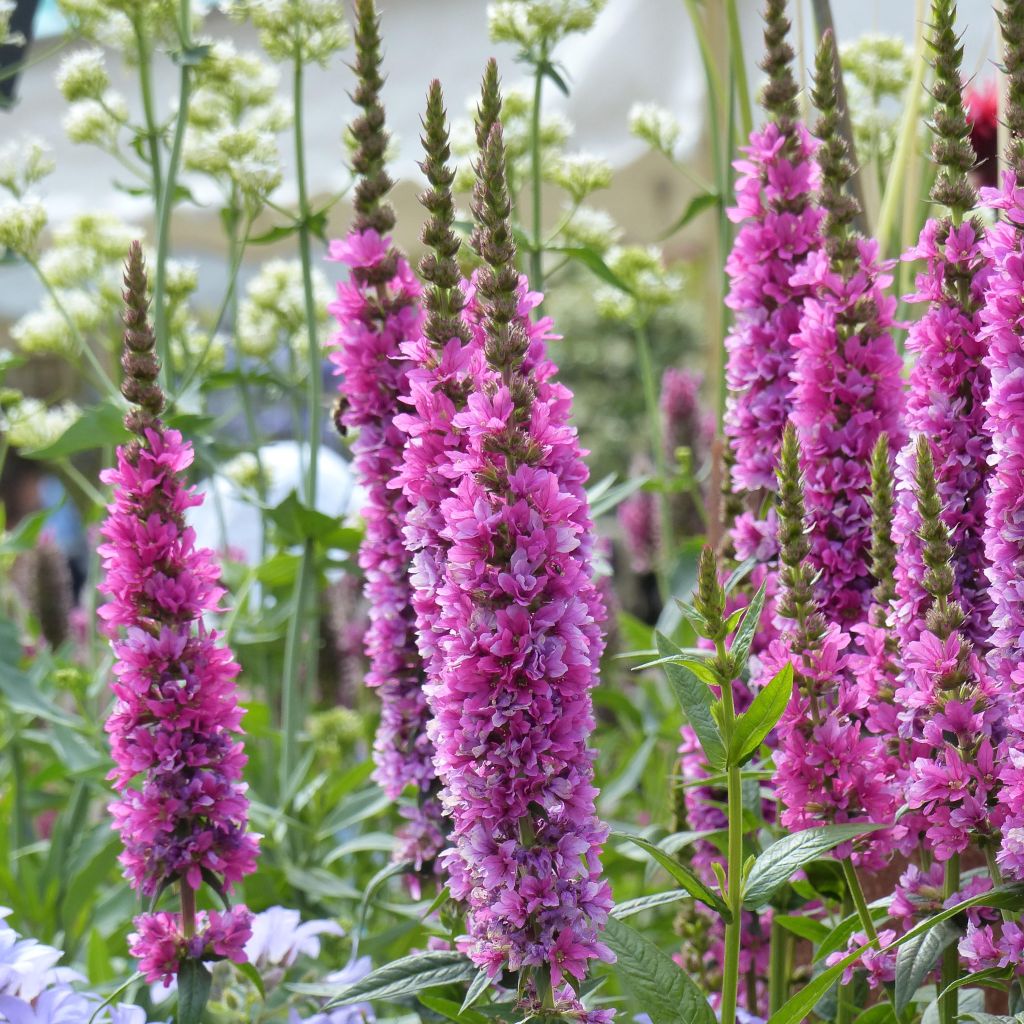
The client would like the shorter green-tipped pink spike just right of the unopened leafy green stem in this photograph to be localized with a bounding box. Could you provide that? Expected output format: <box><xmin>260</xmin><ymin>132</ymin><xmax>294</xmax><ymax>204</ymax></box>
<box><xmin>766</xmin><ymin>426</ymin><xmax>903</xmax><ymax>869</ymax></box>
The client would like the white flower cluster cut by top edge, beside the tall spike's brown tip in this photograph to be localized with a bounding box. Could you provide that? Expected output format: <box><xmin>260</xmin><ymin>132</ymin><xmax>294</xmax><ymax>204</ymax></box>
<box><xmin>226</xmin><ymin>0</ymin><xmax>349</xmax><ymax>65</ymax></box>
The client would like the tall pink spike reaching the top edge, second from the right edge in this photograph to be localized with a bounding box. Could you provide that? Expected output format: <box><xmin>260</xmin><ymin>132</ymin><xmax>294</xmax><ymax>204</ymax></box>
<box><xmin>893</xmin><ymin>0</ymin><xmax>992</xmax><ymax>650</ymax></box>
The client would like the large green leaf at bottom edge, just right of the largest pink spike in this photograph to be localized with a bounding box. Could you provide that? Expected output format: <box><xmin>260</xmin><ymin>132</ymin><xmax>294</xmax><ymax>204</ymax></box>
<box><xmin>604</xmin><ymin>918</ymin><xmax>715</xmax><ymax>1024</ymax></box>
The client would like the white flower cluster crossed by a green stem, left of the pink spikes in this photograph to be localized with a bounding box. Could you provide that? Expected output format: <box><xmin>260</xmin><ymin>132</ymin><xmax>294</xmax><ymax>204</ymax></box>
<box><xmin>237</xmin><ymin>259</ymin><xmax>333</xmax><ymax>367</ymax></box>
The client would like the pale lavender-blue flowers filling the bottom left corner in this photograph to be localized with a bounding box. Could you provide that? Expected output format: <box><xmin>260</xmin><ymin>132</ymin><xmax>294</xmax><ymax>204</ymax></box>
<box><xmin>0</xmin><ymin>906</ymin><xmax>156</xmax><ymax>1024</ymax></box>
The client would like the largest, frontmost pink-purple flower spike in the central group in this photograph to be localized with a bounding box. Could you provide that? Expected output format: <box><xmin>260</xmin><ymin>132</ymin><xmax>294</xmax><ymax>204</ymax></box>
<box><xmin>432</xmin><ymin>124</ymin><xmax>611</xmax><ymax>1007</ymax></box>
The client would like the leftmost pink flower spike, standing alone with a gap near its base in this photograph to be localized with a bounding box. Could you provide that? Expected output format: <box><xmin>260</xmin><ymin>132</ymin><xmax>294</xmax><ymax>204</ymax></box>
<box><xmin>99</xmin><ymin>242</ymin><xmax>258</xmax><ymax>983</ymax></box>
